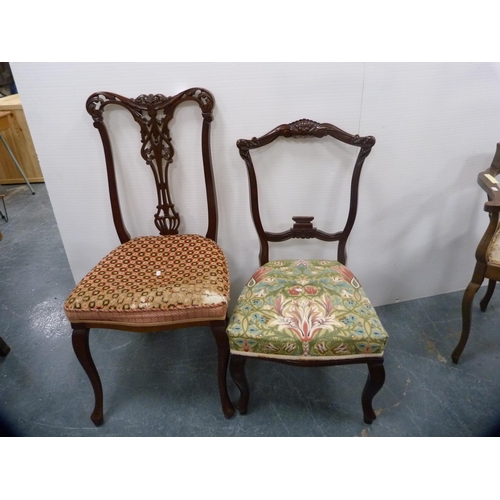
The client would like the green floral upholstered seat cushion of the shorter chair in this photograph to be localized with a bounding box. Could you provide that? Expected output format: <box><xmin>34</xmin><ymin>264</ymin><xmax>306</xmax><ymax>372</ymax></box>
<box><xmin>227</xmin><ymin>260</ymin><xmax>387</xmax><ymax>360</ymax></box>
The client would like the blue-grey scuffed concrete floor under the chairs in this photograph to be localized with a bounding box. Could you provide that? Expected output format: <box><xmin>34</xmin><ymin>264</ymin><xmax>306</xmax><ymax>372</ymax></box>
<box><xmin>0</xmin><ymin>184</ymin><xmax>500</xmax><ymax>437</ymax></box>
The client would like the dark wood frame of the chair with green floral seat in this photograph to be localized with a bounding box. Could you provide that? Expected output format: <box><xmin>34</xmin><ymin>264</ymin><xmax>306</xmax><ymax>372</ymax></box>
<box><xmin>229</xmin><ymin>119</ymin><xmax>385</xmax><ymax>424</ymax></box>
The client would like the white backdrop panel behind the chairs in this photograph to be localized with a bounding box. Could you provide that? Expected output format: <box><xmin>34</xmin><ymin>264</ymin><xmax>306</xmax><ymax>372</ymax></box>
<box><xmin>11</xmin><ymin>63</ymin><xmax>500</xmax><ymax>305</ymax></box>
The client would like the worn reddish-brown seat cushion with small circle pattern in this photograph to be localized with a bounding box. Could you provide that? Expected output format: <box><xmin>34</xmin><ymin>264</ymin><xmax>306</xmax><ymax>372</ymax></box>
<box><xmin>64</xmin><ymin>235</ymin><xmax>229</xmax><ymax>327</ymax></box>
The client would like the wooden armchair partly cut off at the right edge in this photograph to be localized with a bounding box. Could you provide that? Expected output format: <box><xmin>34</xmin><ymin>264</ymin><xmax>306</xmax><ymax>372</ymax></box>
<box><xmin>451</xmin><ymin>142</ymin><xmax>500</xmax><ymax>363</ymax></box>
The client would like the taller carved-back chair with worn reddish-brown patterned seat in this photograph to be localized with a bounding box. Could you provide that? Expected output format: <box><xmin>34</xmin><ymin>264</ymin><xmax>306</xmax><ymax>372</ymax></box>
<box><xmin>64</xmin><ymin>88</ymin><xmax>234</xmax><ymax>425</ymax></box>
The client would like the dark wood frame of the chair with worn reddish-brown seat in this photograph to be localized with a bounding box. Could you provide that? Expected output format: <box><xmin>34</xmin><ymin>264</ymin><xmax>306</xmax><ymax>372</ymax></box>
<box><xmin>72</xmin><ymin>88</ymin><xmax>234</xmax><ymax>426</ymax></box>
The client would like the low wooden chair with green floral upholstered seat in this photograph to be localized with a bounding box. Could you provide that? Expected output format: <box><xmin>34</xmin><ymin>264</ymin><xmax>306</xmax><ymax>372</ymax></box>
<box><xmin>227</xmin><ymin>119</ymin><xmax>387</xmax><ymax>423</ymax></box>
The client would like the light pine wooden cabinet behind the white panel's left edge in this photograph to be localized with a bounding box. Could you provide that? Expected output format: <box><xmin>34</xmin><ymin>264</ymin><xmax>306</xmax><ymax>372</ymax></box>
<box><xmin>0</xmin><ymin>94</ymin><xmax>43</xmax><ymax>184</ymax></box>
